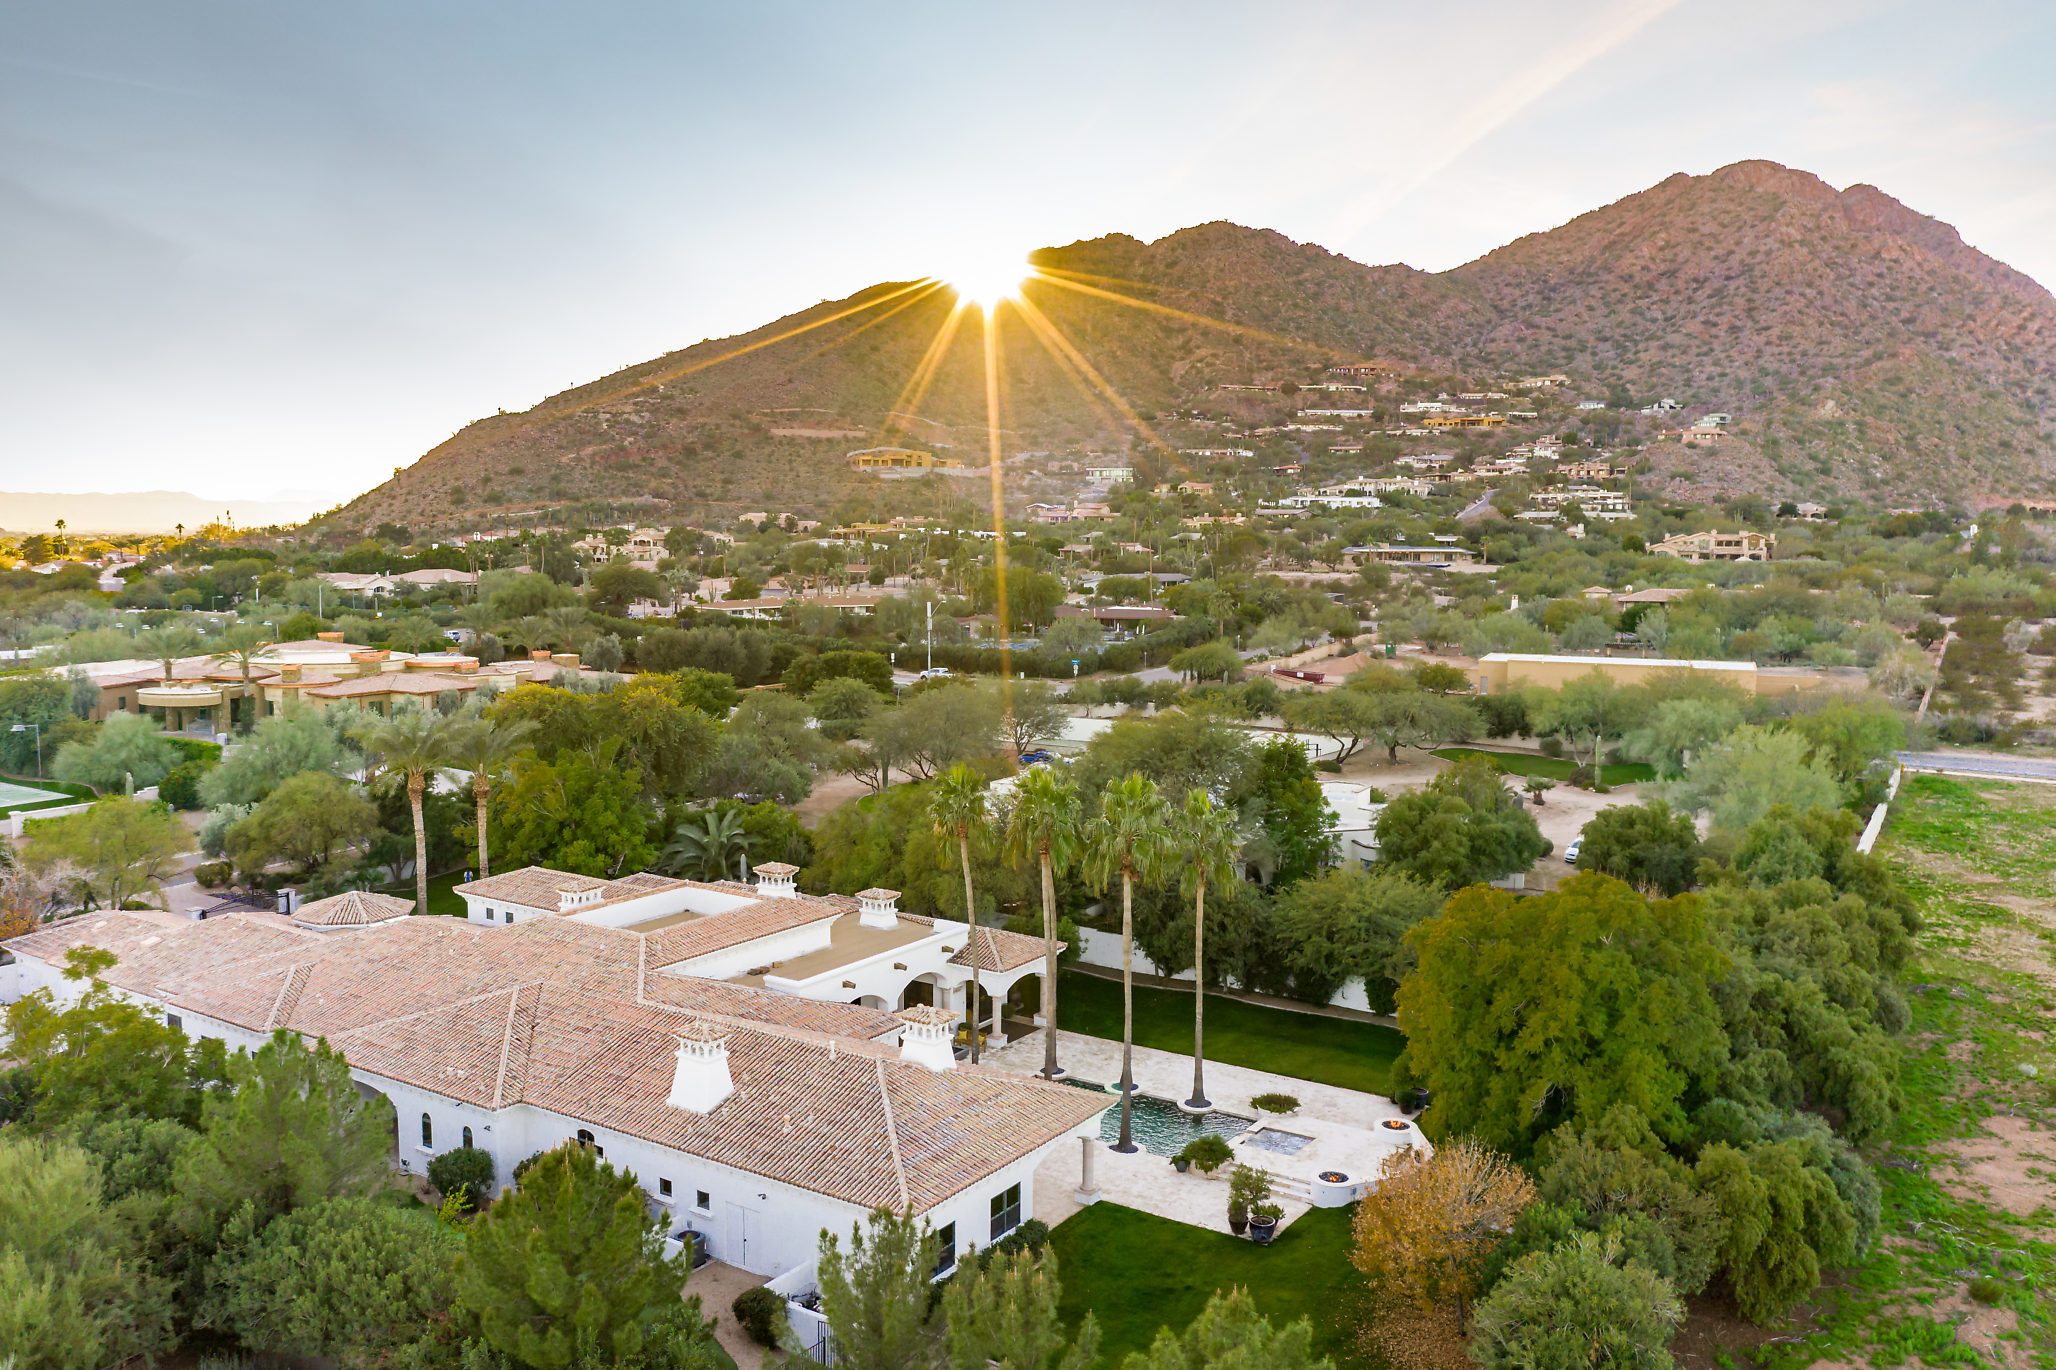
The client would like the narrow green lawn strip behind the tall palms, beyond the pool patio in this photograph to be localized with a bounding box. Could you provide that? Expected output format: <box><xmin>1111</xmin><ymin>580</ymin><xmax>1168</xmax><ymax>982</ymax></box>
<box><xmin>1057</xmin><ymin>971</ymin><xmax>1406</xmax><ymax>1094</ymax></box>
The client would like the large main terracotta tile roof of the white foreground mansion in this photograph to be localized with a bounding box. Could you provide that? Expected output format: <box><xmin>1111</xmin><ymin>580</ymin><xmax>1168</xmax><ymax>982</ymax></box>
<box><xmin>6</xmin><ymin>901</ymin><xmax>1102</xmax><ymax>1210</ymax></box>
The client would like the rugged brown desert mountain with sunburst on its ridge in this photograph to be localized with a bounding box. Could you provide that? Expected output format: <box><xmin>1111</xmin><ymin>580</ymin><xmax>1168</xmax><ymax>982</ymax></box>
<box><xmin>331</xmin><ymin>163</ymin><xmax>2056</xmax><ymax>533</ymax></box>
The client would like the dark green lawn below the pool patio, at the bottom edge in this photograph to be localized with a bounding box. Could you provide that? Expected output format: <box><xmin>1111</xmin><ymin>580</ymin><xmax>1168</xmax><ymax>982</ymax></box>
<box><xmin>1049</xmin><ymin>1185</ymin><xmax>1363</xmax><ymax>1366</ymax></box>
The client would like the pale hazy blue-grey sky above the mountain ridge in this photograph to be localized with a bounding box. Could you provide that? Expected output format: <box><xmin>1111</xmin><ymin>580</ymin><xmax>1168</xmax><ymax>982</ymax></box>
<box><xmin>0</xmin><ymin>0</ymin><xmax>2056</xmax><ymax>506</ymax></box>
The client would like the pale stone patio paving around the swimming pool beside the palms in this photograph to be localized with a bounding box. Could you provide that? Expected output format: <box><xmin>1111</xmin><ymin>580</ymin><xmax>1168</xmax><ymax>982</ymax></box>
<box><xmin>985</xmin><ymin>1031</ymin><xmax>1427</xmax><ymax>1232</ymax></box>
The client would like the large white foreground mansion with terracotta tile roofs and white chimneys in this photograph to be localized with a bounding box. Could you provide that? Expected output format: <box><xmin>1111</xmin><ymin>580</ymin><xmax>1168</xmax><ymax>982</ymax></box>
<box><xmin>0</xmin><ymin>866</ymin><xmax>1104</xmax><ymax>1288</ymax></box>
